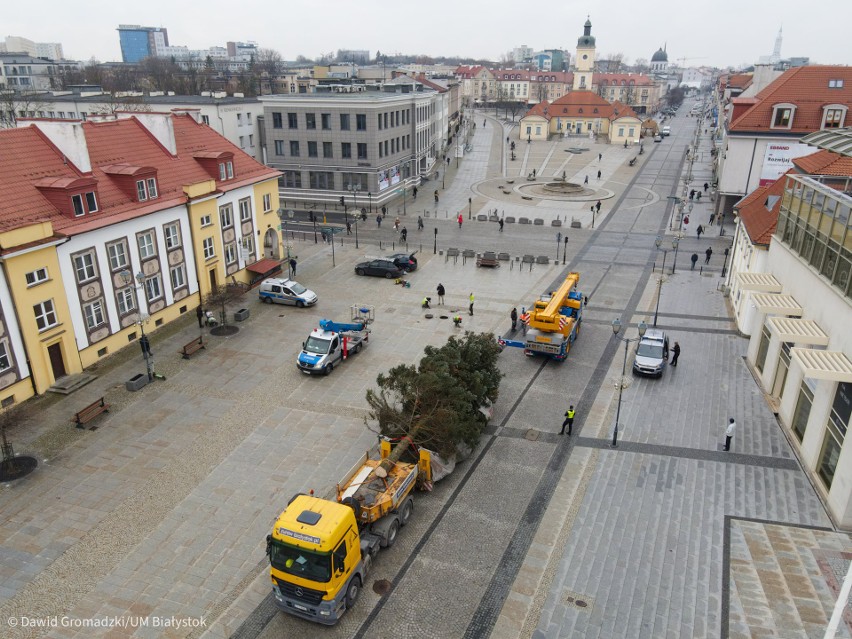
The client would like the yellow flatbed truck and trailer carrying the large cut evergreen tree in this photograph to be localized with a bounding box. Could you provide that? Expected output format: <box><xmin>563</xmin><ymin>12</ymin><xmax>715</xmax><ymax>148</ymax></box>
<box><xmin>266</xmin><ymin>440</ymin><xmax>432</xmax><ymax>625</ymax></box>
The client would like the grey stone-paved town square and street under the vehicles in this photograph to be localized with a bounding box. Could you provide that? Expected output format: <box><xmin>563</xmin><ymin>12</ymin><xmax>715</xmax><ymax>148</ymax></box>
<box><xmin>0</xmin><ymin>102</ymin><xmax>852</xmax><ymax>638</ymax></box>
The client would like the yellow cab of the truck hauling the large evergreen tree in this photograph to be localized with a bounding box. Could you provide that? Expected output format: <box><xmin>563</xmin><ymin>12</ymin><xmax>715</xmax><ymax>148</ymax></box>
<box><xmin>266</xmin><ymin>495</ymin><xmax>367</xmax><ymax>625</ymax></box>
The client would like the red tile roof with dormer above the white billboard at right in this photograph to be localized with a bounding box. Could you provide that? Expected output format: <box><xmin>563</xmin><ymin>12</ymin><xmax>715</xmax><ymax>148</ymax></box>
<box><xmin>729</xmin><ymin>65</ymin><xmax>852</xmax><ymax>135</ymax></box>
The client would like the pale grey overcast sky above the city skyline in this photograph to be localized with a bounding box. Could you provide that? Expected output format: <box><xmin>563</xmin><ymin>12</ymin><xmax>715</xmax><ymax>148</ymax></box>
<box><xmin>2</xmin><ymin>0</ymin><xmax>852</xmax><ymax>67</ymax></box>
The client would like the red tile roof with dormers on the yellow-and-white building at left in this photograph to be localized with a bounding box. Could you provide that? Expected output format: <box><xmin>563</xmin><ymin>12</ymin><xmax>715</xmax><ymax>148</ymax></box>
<box><xmin>0</xmin><ymin>115</ymin><xmax>279</xmax><ymax>235</ymax></box>
